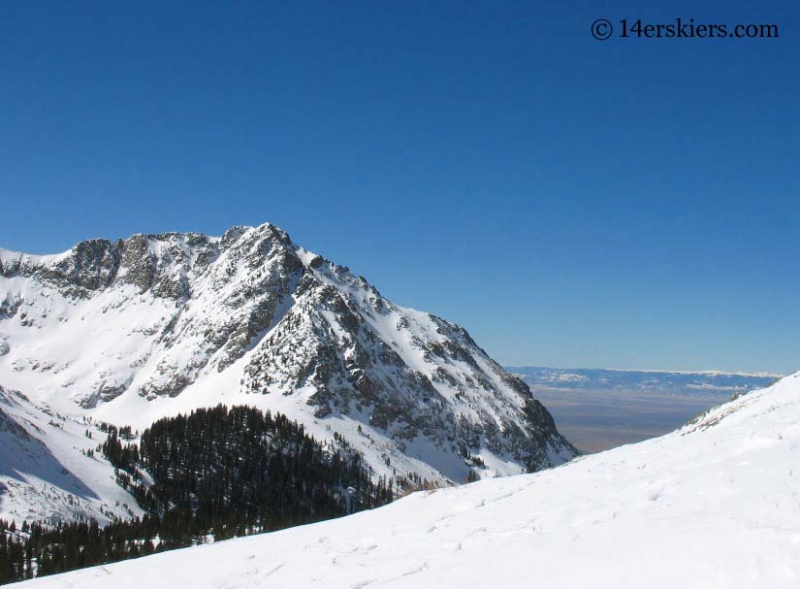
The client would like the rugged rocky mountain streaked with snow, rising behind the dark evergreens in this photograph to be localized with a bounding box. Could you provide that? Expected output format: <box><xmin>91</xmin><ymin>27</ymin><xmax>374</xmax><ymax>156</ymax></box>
<box><xmin>0</xmin><ymin>224</ymin><xmax>575</xmax><ymax>516</ymax></box>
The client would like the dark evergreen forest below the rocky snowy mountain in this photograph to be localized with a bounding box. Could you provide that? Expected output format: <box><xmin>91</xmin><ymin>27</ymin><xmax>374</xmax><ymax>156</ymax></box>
<box><xmin>0</xmin><ymin>405</ymin><xmax>394</xmax><ymax>584</ymax></box>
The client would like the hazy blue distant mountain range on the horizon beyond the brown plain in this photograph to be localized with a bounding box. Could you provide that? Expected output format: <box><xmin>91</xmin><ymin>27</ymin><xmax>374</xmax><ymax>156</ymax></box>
<box><xmin>505</xmin><ymin>366</ymin><xmax>780</xmax><ymax>396</ymax></box>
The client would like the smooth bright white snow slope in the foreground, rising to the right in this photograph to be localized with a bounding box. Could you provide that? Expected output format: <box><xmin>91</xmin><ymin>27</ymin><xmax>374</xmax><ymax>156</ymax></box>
<box><xmin>14</xmin><ymin>373</ymin><xmax>800</xmax><ymax>589</ymax></box>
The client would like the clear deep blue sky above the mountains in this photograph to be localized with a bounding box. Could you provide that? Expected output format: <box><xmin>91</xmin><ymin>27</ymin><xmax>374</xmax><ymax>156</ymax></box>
<box><xmin>0</xmin><ymin>0</ymin><xmax>800</xmax><ymax>373</ymax></box>
